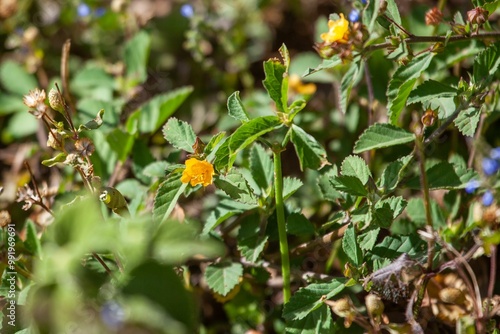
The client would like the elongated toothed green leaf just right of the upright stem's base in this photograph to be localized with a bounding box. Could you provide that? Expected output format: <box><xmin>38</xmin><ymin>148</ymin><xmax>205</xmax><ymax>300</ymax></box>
<box><xmin>283</xmin><ymin>278</ymin><xmax>347</xmax><ymax>320</ymax></box>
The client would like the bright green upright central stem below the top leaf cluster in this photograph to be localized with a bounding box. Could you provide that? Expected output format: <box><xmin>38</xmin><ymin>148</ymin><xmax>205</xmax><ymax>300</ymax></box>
<box><xmin>273</xmin><ymin>145</ymin><xmax>291</xmax><ymax>304</ymax></box>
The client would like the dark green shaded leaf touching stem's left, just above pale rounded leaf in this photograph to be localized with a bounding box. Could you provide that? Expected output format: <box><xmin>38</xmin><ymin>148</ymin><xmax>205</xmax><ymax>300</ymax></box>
<box><xmin>237</xmin><ymin>212</ymin><xmax>268</xmax><ymax>263</ymax></box>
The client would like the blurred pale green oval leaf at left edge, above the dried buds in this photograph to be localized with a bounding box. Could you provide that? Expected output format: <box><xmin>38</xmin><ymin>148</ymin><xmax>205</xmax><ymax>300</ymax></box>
<box><xmin>0</xmin><ymin>60</ymin><xmax>38</xmax><ymax>95</ymax></box>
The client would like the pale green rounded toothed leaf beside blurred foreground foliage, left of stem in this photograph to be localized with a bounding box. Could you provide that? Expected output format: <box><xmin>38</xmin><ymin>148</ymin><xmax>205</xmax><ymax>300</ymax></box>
<box><xmin>204</xmin><ymin>261</ymin><xmax>243</xmax><ymax>296</ymax></box>
